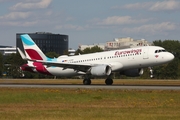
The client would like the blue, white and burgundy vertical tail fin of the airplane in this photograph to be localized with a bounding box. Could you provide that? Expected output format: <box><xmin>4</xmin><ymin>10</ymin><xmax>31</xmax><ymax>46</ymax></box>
<box><xmin>21</xmin><ymin>34</ymin><xmax>47</xmax><ymax>61</ymax></box>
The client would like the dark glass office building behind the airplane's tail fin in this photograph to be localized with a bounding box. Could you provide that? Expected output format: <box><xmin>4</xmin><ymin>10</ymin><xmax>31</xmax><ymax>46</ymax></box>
<box><xmin>16</xmin><ymin>32</ymin><xmax>69</xmax><ymax>55</ymax></box>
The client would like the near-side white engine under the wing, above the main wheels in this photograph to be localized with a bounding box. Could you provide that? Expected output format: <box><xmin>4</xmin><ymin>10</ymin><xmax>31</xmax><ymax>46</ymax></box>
<box><xmin>90</xmin><ymin>65</ymin><xmax>111</xmax><ymax>76</ymax></box>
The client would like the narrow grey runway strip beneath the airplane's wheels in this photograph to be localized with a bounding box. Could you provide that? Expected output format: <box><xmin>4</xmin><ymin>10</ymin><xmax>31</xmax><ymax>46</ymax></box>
<box><xmin>0</xmin><ymin>84</ymin><xmax>180</xmax><ymax>90</ymax></box>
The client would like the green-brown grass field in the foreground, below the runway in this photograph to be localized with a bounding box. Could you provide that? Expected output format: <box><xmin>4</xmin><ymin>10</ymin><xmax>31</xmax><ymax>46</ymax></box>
<box><xmin>0</xmin><ymin>88</ymin><xmax>180</xmax><ymax>120</ymax></box>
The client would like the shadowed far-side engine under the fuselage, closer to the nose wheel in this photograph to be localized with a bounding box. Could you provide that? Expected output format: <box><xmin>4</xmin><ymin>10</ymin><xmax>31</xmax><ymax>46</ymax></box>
<box><xmin>120</xmin><ymin>68</ymin><xmax>143</xmax><ymax>77</ymax></box>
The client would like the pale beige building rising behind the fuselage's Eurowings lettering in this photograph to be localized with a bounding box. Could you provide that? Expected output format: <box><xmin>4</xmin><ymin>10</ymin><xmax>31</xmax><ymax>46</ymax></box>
<box><xmin>79</xmin><ymin>37</ymin><xmax>152</xmax><ymax>50</ymax></box>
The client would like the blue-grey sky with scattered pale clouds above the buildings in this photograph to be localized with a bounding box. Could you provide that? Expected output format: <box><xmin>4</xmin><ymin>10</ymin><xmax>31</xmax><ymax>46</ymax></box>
<box><xmin>0</xmin><ymin>0</ymin><xmax>180</xmax><ymax>49</ymax></box>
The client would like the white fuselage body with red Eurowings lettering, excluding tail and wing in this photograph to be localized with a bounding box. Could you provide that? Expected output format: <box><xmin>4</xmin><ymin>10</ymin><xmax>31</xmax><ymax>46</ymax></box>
<box><xmin>43</xmin><ymin>46</ymin><xmax>174</xmax><ymax>76</ymax></box>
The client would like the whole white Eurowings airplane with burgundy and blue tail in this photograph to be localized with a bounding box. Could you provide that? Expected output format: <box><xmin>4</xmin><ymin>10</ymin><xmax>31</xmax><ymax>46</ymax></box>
<box><xmin>18</xmin><ymin>34</ymin><xmax>174</xmax><ymax>85</ymax></box>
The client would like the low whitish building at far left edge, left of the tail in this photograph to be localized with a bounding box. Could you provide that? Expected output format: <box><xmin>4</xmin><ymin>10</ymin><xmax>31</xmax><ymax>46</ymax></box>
<box><xmin>0</xmin><ymin>46</ymin><xmax>16</xmax><ymax>55</ymax></box>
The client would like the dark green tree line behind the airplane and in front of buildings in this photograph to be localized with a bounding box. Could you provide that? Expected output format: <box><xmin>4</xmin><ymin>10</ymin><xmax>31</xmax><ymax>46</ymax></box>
<box><xmin>0</xmin><ymin>40</ymin><xmax>180</xmax><ymax>79</ymax></box>
